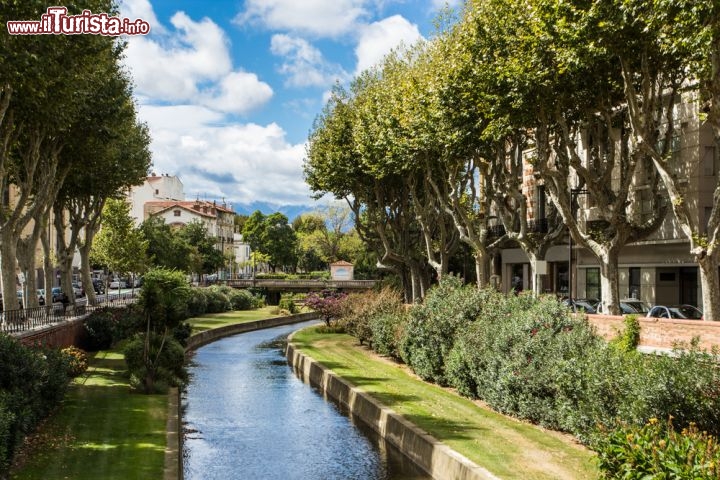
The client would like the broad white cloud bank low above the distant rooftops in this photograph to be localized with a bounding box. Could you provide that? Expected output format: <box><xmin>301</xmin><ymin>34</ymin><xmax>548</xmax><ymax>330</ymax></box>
<box><xmin>139</xmin><ymin>105</ymin><xmax>311</xmax><ymax>205</ymax></box>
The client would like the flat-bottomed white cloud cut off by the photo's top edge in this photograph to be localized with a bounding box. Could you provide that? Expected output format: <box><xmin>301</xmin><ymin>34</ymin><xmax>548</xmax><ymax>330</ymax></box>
<box><xmin>233</xmin><ymin>0</ymin><xmax>368</xmax><ymax>37</ymax></box>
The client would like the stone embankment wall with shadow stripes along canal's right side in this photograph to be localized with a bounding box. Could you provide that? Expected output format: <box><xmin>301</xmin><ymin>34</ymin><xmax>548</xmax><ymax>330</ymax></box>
<box><xmin>287</xmin><ymin>343</ymin><xmax>497</xmax><ymax>480</ymax></box>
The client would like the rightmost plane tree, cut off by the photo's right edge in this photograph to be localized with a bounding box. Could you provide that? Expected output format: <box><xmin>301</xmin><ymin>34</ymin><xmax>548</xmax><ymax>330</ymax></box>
<box><xmin>596</xmin><ymin>0</ymin><xmax>720</xmax><ymax>320</ymax></box>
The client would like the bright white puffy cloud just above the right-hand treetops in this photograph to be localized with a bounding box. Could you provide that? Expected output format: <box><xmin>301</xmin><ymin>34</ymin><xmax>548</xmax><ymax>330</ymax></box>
<box><xmin>355</xmin><ymin>15</ymin><xmax>422</xmax><ymax>73</ymax></box>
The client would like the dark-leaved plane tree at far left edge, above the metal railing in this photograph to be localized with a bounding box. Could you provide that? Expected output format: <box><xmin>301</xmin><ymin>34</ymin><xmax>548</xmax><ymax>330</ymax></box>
<box><xmin>0</xmin><ymin>0</ymin><xmax>120</xmax><ymax>308</ymax></box>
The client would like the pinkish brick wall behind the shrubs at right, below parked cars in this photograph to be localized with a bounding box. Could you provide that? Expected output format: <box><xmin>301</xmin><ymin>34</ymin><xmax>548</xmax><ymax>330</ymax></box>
<box><xmin>588</xmin><ymin>315</ymin><xmax>720</xmax><ymax>350</ymax></box>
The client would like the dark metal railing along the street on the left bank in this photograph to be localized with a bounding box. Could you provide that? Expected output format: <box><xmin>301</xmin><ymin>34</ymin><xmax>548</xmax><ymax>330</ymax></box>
<box><xmin>0</xmin><ymin>292</ymin><xmax>137</xmax><ymax>334</ymax></box>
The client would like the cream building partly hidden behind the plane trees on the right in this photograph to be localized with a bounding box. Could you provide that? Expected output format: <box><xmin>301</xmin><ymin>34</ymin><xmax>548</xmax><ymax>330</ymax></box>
<box><xmin>495</xmin><ymin>103</ymin><xmax>720</xmax><ymax>306</ymax></box>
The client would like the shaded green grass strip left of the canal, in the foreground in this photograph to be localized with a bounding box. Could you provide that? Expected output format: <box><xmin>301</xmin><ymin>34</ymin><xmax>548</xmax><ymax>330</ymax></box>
<box><xmin>10</xmin><ymin>351</ymin><xmax>167</xmax><ymax>480</ymax></box>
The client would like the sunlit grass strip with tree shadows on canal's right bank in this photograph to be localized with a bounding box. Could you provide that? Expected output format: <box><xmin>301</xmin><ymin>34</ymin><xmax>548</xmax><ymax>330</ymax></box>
<box><xmin>293</xmin><ymin>328</ymin><xmax>599</xmax><ymax>480</ymax></box>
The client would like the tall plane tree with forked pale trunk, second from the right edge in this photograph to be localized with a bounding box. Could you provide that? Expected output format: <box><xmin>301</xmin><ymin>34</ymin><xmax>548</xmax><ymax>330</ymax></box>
<box><xmin>464</xmin><ymin>0</ymin><xmax>666</xmax><ymax>313</ymax></box>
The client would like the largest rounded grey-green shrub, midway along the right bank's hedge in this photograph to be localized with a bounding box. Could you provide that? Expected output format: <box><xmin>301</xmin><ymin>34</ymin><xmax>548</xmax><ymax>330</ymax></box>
<box><xmin>448</xmin><ymin>295</ymin><xmax>602</xmax><ymax>428</ymax></box>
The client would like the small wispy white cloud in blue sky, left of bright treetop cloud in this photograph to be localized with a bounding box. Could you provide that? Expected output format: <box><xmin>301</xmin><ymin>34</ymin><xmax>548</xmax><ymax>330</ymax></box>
<box><xmin>270</xmin><ymin>34</ymin><xmax>348</xmax><ymax>87</ymax></box>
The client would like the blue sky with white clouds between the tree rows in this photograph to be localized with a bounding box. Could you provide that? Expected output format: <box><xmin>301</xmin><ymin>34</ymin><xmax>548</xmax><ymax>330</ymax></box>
<box><xmin>115</xmin><ymin>0</ymin><xmax>458</xmax><ymax>216</ymax></box>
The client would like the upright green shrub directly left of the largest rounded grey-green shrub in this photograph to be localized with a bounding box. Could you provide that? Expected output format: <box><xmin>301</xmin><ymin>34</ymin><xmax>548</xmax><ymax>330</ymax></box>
<box><xmin>400</xmin><ymin>276</ymin><xmax>490</xmax><ymax>385</ymax></box>
